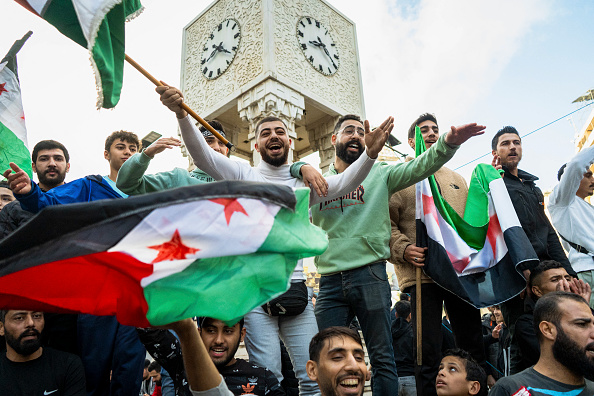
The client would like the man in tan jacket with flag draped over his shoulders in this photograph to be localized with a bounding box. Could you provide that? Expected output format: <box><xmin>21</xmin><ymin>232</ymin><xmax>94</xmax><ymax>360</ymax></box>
<box><xmin>390</xmin><ymin>113</ymin><xmax>487</xmax><ymax>395</ymax></box>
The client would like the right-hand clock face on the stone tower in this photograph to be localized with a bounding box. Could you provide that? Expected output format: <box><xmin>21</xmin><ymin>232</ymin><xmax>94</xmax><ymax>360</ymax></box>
<box><xmin>297</xmin><ymin>17</ymin><xmax>340</xmax><ymax>76</ymax></box>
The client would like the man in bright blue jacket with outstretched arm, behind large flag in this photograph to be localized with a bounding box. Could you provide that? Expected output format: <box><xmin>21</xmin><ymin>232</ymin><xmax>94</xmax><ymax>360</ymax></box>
<box><xmin>4</xmin><ymin>131</ymin><xmax>145</xmax><ymax>396</ymax></box>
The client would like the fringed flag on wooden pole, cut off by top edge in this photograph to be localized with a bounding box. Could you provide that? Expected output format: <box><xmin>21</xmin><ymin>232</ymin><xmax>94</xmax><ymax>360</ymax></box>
<box><xmin>15</xmin><ymin>0</ymin><xmax>143</xmax><ymax>109</ymax></box>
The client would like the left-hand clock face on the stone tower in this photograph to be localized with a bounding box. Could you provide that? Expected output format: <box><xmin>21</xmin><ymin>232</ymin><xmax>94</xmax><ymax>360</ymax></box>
<box><xmin>200</xmin><ymin>18</ymin><xmax>241</xmax><ymax>80</ymax></box>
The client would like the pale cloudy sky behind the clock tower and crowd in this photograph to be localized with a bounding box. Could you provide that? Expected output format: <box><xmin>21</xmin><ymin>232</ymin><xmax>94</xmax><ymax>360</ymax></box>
<box><xmin>0</xmin><ymin>0</ymin><xmax>594</xmax><ymax>190</ymax></box>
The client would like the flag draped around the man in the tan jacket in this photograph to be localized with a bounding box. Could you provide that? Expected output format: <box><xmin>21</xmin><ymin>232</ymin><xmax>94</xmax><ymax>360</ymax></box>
<box><xmin>415</xmin><ymin>127</ymin><xmax>538</xmax><ymax>308</ymax></box>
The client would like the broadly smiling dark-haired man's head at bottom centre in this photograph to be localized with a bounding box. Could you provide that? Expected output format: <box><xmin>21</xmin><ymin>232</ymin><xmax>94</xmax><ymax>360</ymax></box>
<box><xmin>307</xmin><ymin>326</ymin><xmax>368</xmax><ymax>396</ymax></box>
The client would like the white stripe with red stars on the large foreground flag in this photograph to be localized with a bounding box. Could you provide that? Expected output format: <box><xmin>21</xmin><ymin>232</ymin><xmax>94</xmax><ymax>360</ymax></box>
<box><xmin>109</xmin><ymin>198</ymin><xmax>280</xmax><ymax>286</ymax></box>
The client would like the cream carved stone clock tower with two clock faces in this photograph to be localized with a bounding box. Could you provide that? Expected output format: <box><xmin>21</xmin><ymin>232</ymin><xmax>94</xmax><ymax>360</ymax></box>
<box><xmin>181</xmin><ymin>0</ymin><xmax>365</xmax><ymax>170</ymax></box>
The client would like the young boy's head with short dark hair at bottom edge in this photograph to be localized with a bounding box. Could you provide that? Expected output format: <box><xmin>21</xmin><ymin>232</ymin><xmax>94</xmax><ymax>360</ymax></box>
<box><xmin>435</xmin><ymin>349</ymin><xmax>488</xmax><ymax>396</ymax></box>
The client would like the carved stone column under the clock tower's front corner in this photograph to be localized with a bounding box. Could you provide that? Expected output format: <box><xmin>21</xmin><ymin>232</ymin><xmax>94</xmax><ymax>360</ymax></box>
<box><xmin>237</xmin><ymin>79</ymin><xmax>305</xmax><ymax>166</ymax></box>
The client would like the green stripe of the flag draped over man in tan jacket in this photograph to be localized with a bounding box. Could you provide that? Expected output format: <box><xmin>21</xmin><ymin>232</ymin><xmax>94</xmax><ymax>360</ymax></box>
<box><xmin>415</xmin><ymin>125</ymin><xmax>501</xmax><ymax>250</ymax></box>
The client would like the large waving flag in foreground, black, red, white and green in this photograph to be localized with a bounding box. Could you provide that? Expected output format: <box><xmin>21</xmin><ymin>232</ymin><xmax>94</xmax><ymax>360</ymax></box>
<box><xmin>0</xmin><ymin>181</ymin><xmax>328</xmax><ymax>327</ymax></box>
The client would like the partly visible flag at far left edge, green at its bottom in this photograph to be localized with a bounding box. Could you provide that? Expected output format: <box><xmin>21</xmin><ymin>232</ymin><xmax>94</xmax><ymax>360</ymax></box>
<box><xmin>0</xmin><ymin>31</ymin><xmax>33</xmax><ymax>178</ymax></box>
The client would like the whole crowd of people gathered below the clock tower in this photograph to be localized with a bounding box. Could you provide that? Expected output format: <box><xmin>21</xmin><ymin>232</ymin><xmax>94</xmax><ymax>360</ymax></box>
<box><xmin>0</xmin><ymin>81</ymin><xmax>594</xmax><ymax>396</ymax></box>
